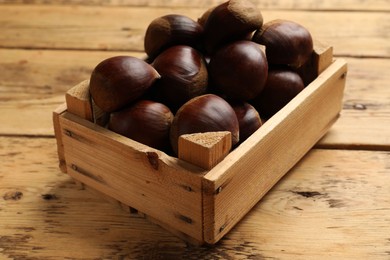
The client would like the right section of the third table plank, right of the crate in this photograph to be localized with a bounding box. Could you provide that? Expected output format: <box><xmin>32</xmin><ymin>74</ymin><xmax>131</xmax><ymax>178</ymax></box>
<box><xmin>318</xmin><ymin>58</ymin><xmax>390</xmax><ymax>150</ymax></box>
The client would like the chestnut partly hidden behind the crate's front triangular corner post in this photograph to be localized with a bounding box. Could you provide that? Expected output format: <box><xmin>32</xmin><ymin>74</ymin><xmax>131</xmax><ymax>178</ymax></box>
<box><xmin>170</xmin><ymin>94</ymin><xmax>239</xmax><ymax>154</ymax></box>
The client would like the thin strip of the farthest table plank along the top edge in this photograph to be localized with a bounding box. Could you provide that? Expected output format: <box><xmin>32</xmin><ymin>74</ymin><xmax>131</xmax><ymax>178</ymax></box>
<box><xmin>0</xmin><ymin>0</ymin><xmax>390</xmax><ymax>11</ymax></box>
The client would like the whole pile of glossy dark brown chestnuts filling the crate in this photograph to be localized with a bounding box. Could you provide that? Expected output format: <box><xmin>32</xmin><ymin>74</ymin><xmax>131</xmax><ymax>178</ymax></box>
<box><xmin>90</xmin><ymin>0</ymin><xmax>313</xmax><ymax>155</ymax></box>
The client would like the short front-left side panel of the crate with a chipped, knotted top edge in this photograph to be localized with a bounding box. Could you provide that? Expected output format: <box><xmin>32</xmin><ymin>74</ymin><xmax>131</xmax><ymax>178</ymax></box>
<box><xmin>60</xmin><ymin>113</ymin><xmax>203</xmax><ymax>241</ymax></box>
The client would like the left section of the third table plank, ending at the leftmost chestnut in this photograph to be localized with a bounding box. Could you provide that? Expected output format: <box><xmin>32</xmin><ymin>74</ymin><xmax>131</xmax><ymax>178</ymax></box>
<box><xmin>0</xmin><ymin>49</ymin><xmax>139</xmax><ymax>136</ymax></box>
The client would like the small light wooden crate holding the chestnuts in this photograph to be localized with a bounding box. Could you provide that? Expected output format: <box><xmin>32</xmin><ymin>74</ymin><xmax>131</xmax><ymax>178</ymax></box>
<box><xmin>53</xmin><ymin>43</ymin><xmax>347</xmax><ymax>244</ymax></box>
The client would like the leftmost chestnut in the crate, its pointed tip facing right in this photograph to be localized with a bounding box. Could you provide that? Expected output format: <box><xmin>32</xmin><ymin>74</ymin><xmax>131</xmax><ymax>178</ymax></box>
<box><xmin>89</xmin><ymin>56</ymin><xmax>160</xmax><ymax>113</ymax></box>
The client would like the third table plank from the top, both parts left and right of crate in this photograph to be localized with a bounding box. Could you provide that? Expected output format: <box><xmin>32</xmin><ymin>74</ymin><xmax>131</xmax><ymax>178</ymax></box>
<box><xmin>0</xmin><ymin>49</ymin><xmax>390</xmax><ymax>149</ymax></box>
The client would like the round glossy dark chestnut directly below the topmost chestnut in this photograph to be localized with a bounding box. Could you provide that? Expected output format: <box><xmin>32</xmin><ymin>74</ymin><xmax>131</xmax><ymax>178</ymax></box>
<box><xmin>209</xmin><ymin>41</ymin><xmax>268</xmax><ymax>101</ymax></box>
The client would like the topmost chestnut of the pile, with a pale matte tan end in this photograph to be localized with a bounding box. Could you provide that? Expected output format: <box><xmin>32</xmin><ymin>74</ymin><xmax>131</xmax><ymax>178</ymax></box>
<box><xmin>203</xmin><ymin>0</ymin><xmax>263</xmax><ymax>53</ymax></box>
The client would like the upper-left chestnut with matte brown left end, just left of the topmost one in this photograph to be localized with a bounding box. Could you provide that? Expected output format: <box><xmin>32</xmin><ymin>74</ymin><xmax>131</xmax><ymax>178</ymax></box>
<box><xmin>144</xmin><ymin>14</ymin><xmax>203</xmax><ymax>58</ymax></box>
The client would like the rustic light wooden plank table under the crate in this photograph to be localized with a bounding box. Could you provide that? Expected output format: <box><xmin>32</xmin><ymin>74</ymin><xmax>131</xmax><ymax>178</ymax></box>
<box><xmin>0</xmin><ymin>0</ymin><xmax>390</xmax><ymax>259</ymax></box>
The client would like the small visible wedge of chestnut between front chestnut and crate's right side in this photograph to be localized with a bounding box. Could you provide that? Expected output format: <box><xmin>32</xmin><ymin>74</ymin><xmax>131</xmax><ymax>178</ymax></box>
<box><xmin>231</xmin><ymin>102</ymin><xmax>262</xmax><ymax>143</ymax></box>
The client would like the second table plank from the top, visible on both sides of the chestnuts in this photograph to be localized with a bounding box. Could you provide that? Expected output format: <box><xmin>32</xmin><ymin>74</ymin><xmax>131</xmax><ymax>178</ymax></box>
<box><xmin>0</xmin><ymin>5</ymin><xmax>390</xmax><ymax>57</ymax></box>
